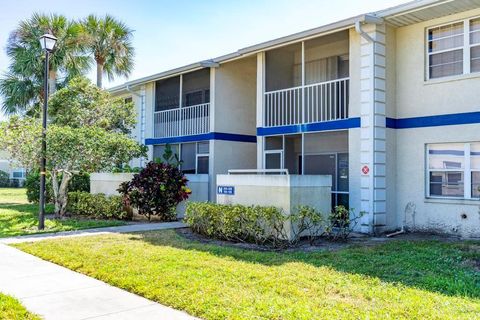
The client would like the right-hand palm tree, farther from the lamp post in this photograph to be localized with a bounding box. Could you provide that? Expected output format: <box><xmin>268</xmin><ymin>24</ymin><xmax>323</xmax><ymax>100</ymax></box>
<box><xmin>82</xmin><ymin>14</ymin><xmax>134</xmax><ymax>88</ymax></box>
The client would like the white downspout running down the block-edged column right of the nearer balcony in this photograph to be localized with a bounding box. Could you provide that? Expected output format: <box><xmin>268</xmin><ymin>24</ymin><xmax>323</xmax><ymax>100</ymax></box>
<box><xmin>355</xmin><ymin>14</ymin><xmax>383</xmax><ymax>234</ymax></box>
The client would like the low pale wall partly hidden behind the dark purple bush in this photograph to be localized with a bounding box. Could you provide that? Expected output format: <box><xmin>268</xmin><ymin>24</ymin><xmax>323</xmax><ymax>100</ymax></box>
<box><xmin>90</xmin><ymin>173</ymin><xmax>209</xmax><ymax>218</ymax></box>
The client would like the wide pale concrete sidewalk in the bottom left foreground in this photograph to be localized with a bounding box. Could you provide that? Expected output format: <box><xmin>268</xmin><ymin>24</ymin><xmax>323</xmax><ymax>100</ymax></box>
<box><xmin>0</xmin><ymin>244</ymin><xmax>196</xmax><ymax>320</ymax></box>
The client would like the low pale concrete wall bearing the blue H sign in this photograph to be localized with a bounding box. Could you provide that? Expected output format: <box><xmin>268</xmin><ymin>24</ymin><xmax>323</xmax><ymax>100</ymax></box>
<box><xmin>217</xmin><ymin>175</ymin><xmax>332</xmax><ymax>237</ymax></box>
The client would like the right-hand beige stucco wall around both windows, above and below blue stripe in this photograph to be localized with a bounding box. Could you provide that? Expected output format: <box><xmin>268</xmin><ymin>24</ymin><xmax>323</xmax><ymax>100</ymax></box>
<box><xmin>389</xmin><ymin>9</ymin><xmax>480</xmax><ymax>237</ymax></box>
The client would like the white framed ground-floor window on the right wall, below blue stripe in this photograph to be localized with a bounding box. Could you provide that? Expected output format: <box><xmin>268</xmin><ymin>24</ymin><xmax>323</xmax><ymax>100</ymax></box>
<box><xmin>426</xmin><ymin>142</ymin><xmax>480</xmax><ymax>199</ymax></box>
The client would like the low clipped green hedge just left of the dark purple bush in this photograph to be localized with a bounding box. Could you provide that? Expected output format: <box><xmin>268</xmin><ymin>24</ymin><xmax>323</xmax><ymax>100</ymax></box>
<box><xmin>67</xmin><ymin>191</ymin><xmax>132</xmax><ymax>220</ymax></box>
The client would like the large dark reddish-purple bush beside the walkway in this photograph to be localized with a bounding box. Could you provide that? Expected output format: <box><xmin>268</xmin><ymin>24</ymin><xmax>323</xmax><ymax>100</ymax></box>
<box><xmin>118</xmin><ymin>162</ymin><xmax>191</xmax><ymax>221</ymax></box>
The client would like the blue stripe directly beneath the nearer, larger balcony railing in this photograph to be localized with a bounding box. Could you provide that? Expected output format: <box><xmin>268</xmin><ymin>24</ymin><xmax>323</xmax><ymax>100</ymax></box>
<box><xmin>257</xmin><ymin>118</ymin><xmax>360</xmax><ymax>136</ymax></box>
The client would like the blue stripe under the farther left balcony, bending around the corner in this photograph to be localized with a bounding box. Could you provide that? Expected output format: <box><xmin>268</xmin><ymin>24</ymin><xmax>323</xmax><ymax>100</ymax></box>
<box><xmin>145</xmin><ymin>132</ymin><xmax>257</xmax><ymax>145</ymax></box>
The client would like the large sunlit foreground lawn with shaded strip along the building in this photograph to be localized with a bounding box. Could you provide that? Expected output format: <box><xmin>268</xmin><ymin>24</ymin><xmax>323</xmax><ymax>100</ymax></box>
<box><xmin>15</xmin><ymin>230</ymin><xmax>480</xmax><ymax>320</ymax></box>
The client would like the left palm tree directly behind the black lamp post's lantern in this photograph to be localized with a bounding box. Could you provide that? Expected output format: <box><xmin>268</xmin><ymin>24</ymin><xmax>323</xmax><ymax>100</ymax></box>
<box><xmin>0</xmin><ymin>13</ymin><xmax>92</xmax><ymax>114</ymax></box>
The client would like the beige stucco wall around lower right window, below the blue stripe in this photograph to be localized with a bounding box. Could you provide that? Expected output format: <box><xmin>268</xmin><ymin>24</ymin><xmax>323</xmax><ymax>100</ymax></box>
<box><xmin>396</xmin><ymin>125</ymin><xmax>480</xmax><ymax>237</ymax></box>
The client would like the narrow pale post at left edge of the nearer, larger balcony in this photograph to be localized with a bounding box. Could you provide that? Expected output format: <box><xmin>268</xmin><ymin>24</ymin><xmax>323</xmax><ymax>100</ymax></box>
<box><xmin>257</xmin><ymin>52</ymin><xmax>265</xmax><ymax>169</ymax></box>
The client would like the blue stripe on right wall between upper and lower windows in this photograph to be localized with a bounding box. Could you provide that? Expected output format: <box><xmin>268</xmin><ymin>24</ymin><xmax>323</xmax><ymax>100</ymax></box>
<box><xmin>387</xmin><ymin>112</ymin><xmax>480</xmax><ymax>129</ymax></box>
